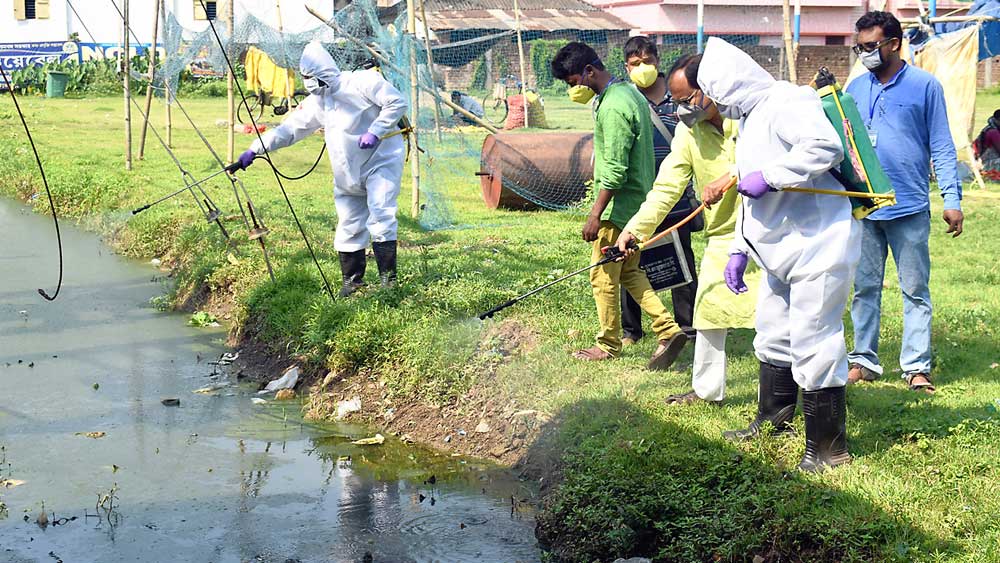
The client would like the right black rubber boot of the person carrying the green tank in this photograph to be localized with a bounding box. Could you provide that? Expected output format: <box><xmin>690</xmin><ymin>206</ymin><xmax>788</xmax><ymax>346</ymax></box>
<box><xmin>799</xmin><ymin>387</ymin><xmax>851</xmax><ymax>473</ymax></box>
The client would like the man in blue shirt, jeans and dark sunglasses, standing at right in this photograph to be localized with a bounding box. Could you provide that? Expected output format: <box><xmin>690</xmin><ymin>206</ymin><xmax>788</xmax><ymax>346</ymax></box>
<box><xmin>847</xmin><ymin>11</ymin><xmax>963</xmax><ymax>392</ymax></box>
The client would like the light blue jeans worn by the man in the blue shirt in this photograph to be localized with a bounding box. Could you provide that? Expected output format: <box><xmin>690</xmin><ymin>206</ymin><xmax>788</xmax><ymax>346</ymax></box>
<box><xmin>847</xmin><ymin>211</ymin><xmax>931</xmax><ymax>379</ymax></box>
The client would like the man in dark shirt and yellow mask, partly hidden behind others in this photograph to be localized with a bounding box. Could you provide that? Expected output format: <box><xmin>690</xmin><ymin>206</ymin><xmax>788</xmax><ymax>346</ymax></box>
<box><xmin>622</xmin><ymin>35</ymin><xmax>698</xmax><ymax>346</ymax></box>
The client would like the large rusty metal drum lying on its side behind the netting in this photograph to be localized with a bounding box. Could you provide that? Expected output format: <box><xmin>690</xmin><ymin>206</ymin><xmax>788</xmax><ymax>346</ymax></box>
<box><xmin>477</xmin><ymin>132</ymin><xmax>594</xmax><ymax>209</ymax></box>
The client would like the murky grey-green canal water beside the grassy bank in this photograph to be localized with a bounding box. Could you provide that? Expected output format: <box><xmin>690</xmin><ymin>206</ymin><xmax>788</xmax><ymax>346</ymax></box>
<box><xmin>0</xmin><ymin>199</ymin><xmax>539</xmax><ymax>563</ymax></box>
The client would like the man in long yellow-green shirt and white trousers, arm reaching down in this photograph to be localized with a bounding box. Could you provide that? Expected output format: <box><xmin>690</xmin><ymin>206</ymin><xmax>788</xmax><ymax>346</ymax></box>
<box><xmin>616</xmin><ymin>55</ymin><xmax>759</xmax><ymax>403</ymax></box>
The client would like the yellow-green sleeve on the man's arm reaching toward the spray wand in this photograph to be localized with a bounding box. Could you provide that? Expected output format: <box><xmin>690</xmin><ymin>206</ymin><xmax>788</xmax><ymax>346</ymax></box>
<box><xmin>624</xmin><ymin>123</ymin><xmax>693</xmax><ymax>241</ymax></box>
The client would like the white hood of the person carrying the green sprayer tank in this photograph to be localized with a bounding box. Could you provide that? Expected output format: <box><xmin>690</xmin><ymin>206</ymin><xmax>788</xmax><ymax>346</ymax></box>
<box><xmin>698</xmin><ymin>37</ymin><xmax>775</xmax><ymax>116</ymax></box>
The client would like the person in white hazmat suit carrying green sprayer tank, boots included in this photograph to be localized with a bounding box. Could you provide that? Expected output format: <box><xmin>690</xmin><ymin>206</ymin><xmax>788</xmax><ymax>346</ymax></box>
<box><xmin>698</xmin><ymin>37</ymin><xmax>861</xmax><ymax>471</ymax></box>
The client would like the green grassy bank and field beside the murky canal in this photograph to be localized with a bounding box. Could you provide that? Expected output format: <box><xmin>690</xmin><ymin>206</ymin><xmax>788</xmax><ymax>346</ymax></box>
<box><xmin>0</xmin><ymin>97</ymin><xmax>1000</xmax><ymax>562</ymax></box>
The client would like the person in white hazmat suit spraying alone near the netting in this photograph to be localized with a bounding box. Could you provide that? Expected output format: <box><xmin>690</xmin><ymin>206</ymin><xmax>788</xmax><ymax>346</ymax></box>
<box><xmin>239</xmin><ymin>41</ymin><xmax>407</xmax><ymax>297</ymax></box>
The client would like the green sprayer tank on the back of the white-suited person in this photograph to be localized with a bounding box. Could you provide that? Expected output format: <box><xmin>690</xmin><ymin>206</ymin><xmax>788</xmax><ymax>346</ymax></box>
<box><xmin>814</xmin><ymin>68</ymin><xmax>896</xmax><ymax>219</ymax></box>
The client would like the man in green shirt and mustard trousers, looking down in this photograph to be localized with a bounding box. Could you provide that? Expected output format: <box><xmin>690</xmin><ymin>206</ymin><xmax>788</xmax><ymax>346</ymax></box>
<box><xmin>552</xmin><ymin>42</ymin><xmax>687</xmax><ymax>370</ymax></box>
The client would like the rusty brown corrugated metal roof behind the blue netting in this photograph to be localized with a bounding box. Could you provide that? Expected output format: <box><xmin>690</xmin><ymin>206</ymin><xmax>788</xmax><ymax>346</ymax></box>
<box><xmin>427</xmin><ymin>8</ymin><xmax>631</xmax><ymax>31</ymax></box>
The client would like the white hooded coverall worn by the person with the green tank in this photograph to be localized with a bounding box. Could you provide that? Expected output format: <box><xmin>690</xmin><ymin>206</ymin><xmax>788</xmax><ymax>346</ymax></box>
<box><xmin>698</xmin><ymin>37</ymin><xmax>861</xmax><ymax>391</ymax></box>
